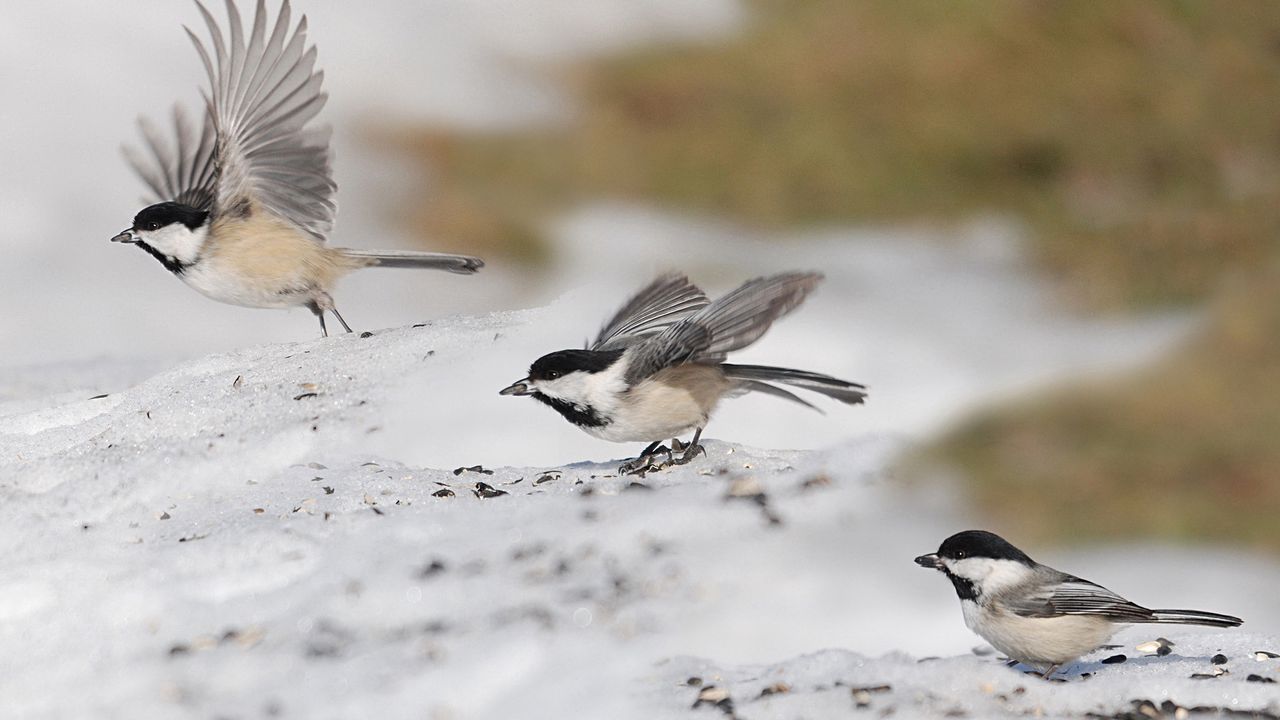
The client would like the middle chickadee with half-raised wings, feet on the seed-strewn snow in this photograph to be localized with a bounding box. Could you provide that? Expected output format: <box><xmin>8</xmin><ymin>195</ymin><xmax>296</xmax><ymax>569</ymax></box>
<box><xmin>502</xmin><ymin>273</ymin><xmax>867</xmax><ymax>473</ymax></box>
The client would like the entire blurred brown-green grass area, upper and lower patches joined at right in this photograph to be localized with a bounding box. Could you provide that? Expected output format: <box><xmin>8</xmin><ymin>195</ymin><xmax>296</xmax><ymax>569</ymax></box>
<box><xmin>394</xmin><ymin>0</ymin><xmax>1280</xmax><ymax>548</ymax></box>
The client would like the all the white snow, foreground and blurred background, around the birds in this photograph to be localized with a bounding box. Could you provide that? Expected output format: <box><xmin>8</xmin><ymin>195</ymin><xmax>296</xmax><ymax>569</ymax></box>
<box><xmin>0</xmin><ymin>0</ymin><xmax>1280</xmax><ymax>720</ymax></box>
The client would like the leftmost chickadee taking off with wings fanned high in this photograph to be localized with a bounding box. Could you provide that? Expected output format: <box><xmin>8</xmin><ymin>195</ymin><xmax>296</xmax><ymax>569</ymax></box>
<box><xmin>111</xmin><ymin>0</ymin><xmax>484</xmax><ymax>336</ymax></box>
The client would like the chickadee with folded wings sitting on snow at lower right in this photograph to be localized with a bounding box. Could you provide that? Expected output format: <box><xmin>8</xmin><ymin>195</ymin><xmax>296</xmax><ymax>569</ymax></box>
<box><xmin>915</xmin><ymin>530</ymin><xmax>1243</xmax><ymax>678</ymax></box>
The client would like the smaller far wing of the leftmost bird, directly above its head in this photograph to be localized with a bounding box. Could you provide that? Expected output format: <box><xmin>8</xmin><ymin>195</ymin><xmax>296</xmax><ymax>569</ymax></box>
<box><xmin>124</xmin><ymin>105</ymin><xmax>218</xmax><ymax>210</ymax></box>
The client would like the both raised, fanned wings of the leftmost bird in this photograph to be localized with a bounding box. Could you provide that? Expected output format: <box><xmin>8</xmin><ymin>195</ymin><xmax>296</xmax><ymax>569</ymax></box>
<box><xmin>125</xmin><ymin>0</ymin><xmax>337</xmax><ymax>241</ymax></box>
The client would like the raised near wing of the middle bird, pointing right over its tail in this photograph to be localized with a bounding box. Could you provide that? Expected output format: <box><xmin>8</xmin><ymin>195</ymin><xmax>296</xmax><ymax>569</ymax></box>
<box><xmin>626</xmin><ymin>273</ymin><xmax>822</xmax><ymax>383</ymax></box>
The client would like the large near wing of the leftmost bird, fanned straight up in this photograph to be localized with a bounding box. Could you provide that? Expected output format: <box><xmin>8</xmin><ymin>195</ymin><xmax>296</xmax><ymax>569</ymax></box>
<box><xmin>187</xmin><ymin>0</ymin><xmax>337</xmax><ymax>241</ymax></box>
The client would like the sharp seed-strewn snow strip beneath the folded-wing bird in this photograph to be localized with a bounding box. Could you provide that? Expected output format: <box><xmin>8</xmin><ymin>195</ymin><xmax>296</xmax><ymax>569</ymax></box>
<box><xmin>648</xmin><ymin>640</ymin><xmax>1280</xmax><ymax>720</ymax></box>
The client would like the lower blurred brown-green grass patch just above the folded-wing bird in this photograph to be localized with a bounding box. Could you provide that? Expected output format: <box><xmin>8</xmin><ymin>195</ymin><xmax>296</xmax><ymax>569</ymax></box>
<box><xmin>913</xmin><ymin>265</ymin><xmax>1280</xmax><ymax>552</ymax></box>
